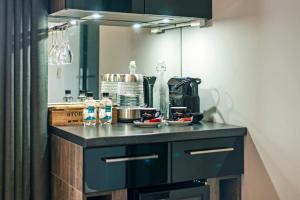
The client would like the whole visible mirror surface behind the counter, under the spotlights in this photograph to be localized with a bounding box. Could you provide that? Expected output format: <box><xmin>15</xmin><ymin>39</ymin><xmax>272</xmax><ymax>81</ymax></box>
<box><xmin>48</xmin><ymin>23</ymin><xmax>181</xmax><ymax>103</ymax></box>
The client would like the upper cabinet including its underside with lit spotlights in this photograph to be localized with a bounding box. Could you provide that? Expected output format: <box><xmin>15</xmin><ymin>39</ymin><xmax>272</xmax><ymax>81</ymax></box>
<box><xmin>49</xmin><ymin>0</ymin><xmax>212</xmax><ymax>29</ymax></box>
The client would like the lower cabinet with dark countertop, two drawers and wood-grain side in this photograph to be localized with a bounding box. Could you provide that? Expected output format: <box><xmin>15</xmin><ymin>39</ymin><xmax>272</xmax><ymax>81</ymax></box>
<box><xmin>49</xmin><ymin>122</ymin><xmax>246</xmax><ymax>200</ymax></box>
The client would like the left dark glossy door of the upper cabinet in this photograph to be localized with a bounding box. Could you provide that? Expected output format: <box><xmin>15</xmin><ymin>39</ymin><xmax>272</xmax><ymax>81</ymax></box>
<box><xmin>66</xmin><ymin>0</ymin><xmax>144</xmax><ymax>13</ymax></box>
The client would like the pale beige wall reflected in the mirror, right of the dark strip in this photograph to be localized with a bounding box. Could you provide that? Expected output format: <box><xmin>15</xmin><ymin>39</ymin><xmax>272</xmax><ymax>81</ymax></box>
<box><xmin>99</xmin><ymin>26</ymin><xmax>181</xmax><ymax>80</ymax></box>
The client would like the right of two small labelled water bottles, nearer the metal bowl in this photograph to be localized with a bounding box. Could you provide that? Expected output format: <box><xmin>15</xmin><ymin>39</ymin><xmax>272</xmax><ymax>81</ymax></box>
<box><xmin>99</xmin><ymin>92</ymin><xmax>113</xmax><ymax>125</ymax></box>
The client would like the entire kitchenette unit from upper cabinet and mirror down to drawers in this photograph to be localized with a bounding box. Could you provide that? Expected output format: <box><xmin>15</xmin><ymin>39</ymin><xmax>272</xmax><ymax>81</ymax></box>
<box><xmin>48</xmin><ymin>0</ymin><xmax>247</xmax><ymax>200</ymax></box>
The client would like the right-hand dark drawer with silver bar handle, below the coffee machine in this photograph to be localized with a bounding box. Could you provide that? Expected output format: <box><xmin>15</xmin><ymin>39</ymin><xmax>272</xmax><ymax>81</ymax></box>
<box><xmin>172</xmin><ymin>137</ymin><xmax>244</xmax><ymax>182</ymax></box>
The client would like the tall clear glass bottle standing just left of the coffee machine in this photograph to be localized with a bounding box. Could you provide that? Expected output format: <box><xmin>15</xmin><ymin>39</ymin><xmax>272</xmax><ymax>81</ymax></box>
<box><xmin>153</xmin><ymin>61</ymin><xmax>169</xmax><ymax>119</ymax></box>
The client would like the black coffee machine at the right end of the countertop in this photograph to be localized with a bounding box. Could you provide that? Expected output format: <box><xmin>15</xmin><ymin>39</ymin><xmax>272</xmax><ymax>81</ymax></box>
<box><xmin>168</xmin><ymin>77</ymin><xmax>203</xmax><ymax>122</ymax></box>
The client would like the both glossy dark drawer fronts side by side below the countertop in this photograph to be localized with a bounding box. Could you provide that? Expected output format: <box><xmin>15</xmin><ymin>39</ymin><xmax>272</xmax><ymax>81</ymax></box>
<box><xmin>84</xmin><ymin>137</ymin><xmax>244</xmax><ymax>193</ymax></box>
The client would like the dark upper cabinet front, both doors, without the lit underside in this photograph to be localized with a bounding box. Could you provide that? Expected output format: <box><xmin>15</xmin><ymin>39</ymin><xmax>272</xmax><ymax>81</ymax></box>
<box><xmin>50</xmin><ymin>0</ymin><xmax>212</xmax><ymax>19</ymax></box>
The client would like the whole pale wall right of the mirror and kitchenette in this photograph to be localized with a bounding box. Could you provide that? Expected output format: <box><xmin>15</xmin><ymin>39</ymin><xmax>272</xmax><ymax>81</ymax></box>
<box><xmin>183</xmin><ymin>0</ymin><xmax>300</xmax><ymax>200</ymax></box>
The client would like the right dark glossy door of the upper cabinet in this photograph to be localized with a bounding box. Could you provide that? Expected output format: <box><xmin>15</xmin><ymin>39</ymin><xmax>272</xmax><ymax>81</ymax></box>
<box><xmin>145</xmin><ymin>0</ymin><xmax>212</xmax><ymax>19</ymax></box>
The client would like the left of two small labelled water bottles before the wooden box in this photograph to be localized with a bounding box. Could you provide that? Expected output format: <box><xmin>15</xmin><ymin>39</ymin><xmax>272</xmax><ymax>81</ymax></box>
<box><xmin>83</xmin><ymin>92</ymin><xmax>97</xmax><ymax>126</ymax></box>
